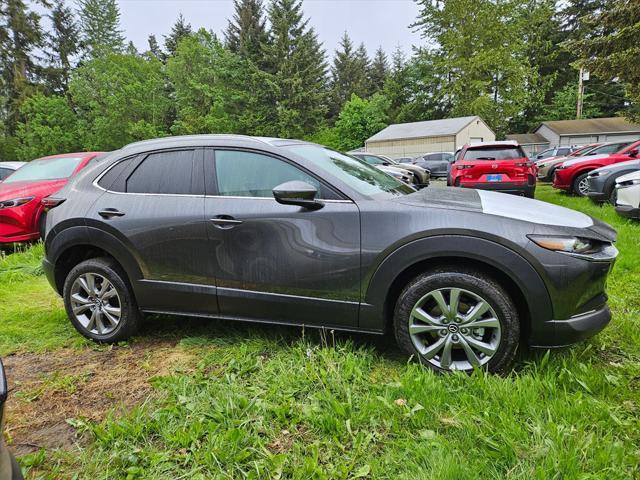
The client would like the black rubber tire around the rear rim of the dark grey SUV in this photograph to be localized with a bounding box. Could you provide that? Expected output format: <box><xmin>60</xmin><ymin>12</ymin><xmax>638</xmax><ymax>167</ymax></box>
<box><xmin>63</xmin><ymin>257</ymin><xmax>141</xmax><ymax>343</ymax></box>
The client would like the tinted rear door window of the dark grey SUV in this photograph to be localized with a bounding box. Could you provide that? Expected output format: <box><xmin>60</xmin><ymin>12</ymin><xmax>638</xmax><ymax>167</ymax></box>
<box><xmin>125</xmin><ymin>150</ymin><xmax>204</xmax><ymax>195</ymax></box>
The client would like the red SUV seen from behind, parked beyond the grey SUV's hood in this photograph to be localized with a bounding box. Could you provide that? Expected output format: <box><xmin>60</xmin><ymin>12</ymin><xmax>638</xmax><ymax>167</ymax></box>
<box><xmin>449</xmin><ymin>141</ymin><xmax>537</xmax><ymax>198</ymax></box>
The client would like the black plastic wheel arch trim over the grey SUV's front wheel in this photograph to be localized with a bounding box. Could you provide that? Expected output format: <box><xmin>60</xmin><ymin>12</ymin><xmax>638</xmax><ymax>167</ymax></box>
<box><xmin>360</xmin><ymin>235</ymin><xmax>553</xmax><ymax>330</ymax></box>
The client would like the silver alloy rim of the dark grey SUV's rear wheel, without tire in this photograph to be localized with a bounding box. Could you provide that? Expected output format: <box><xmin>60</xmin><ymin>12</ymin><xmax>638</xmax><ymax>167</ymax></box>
<box><xmin>70</xmin><ymin>273</ymin><xmax>122</xmax><ymax>335</ymax></box>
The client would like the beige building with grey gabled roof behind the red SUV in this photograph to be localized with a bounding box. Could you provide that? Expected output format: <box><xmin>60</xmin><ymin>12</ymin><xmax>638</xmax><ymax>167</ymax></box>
<box><xmin>365</xmin><ymin>116</ymin><xmax>496</xmax><ymax>158</ymax></box>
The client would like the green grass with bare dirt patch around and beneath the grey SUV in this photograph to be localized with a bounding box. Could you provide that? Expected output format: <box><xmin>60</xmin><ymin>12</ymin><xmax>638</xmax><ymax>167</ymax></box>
<box><xmin>0</xmin><ymin>186</ymin><xmax>640</xmax><ymax>480</ymax></box>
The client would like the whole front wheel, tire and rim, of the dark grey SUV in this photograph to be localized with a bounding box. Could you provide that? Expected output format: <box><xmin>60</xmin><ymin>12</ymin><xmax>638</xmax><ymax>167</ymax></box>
<box><xmin>394</xmin><ymin>267</ymin><xmax>520</xmax><ymax>373</ymax></box>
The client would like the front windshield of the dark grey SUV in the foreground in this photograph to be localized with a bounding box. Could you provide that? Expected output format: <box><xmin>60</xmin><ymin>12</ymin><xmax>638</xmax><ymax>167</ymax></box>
<box><xmin>284</xmin><ymin>145</ymin><xmax>415</xmax><ymax>198</ymax></box>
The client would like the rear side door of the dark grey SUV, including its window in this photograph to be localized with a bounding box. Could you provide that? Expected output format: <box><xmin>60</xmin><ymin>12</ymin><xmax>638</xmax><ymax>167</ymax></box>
<box><xmin>89</xmin><ymin>148</ymin><xmax>217</xmax><ymax>313</ymax></box>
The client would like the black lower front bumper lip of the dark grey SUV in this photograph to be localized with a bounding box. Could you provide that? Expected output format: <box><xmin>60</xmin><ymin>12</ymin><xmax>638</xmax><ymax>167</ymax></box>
<box><xmin>529</xmin><ymin>304</ymin><xmax>611</xmax><ymax>348</ymax></box>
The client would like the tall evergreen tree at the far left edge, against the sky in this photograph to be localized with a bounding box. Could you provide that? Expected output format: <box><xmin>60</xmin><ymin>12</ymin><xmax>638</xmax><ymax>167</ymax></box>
<box><xmin>0</xmin><ymin>0</ymin><xmax>46</xmax><ymax>135</ymax></box>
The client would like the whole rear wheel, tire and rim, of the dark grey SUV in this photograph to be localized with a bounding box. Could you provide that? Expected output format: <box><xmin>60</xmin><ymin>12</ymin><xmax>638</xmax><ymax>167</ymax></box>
<box><xmin>63</xmin><ymin>257</ymin><xmax>140</xmax><ymax>343</ymax></box>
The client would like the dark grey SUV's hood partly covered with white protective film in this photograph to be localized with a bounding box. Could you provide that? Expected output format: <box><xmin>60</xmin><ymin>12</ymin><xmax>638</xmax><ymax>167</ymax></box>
<box><xmin>393</xmin><ymin>187</ymin><xmax>594</xmax><ymax>228</ymax></box>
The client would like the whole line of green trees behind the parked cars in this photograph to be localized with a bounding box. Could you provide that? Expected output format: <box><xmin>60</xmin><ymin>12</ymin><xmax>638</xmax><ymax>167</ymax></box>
<box><xmin>0</xmin><ymin>0</ymin><xmax>640</xmax><ymax>160</ymax></box>
